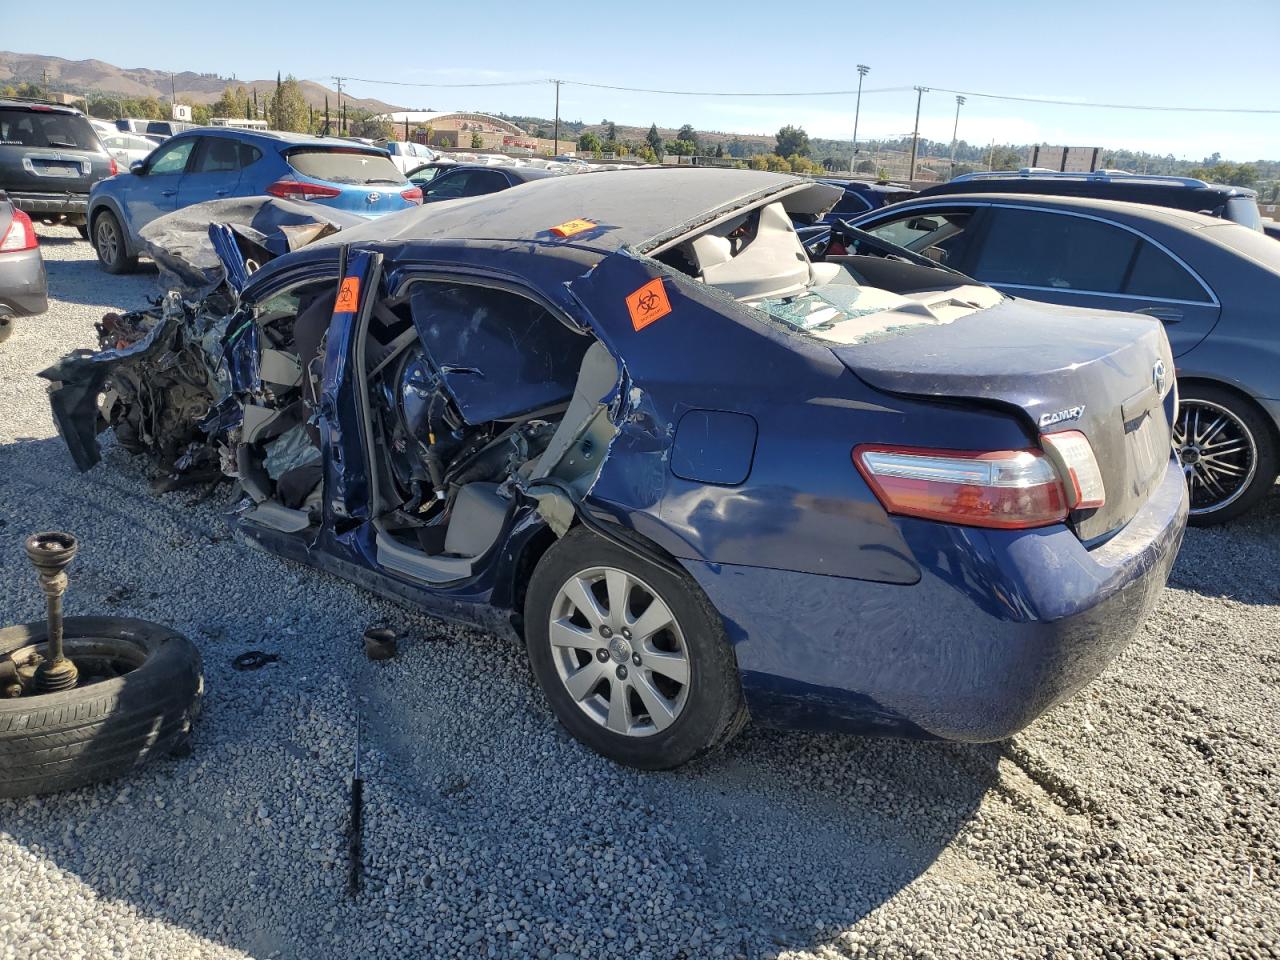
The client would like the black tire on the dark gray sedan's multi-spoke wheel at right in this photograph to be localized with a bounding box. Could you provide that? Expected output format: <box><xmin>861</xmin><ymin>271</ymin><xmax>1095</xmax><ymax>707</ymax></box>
<box><xmin>1174</xmin><ymin>383</ymin><xmax>1280</xmax><ymax>526</ymax></box>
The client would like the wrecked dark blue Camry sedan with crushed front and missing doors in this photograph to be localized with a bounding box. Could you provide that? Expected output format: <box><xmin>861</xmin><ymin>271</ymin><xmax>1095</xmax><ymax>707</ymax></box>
<box><xmin>45</xmin><ymin>169</ymin><xmax>1187</xmax><ymax>768</ymax></box>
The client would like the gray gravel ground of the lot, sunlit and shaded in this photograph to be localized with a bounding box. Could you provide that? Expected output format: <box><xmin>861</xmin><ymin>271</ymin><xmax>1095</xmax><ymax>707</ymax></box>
<box><xmin>0</xmin><ymin>228</ymin><xmax>1280</xmax><ymax>960</ymax></box>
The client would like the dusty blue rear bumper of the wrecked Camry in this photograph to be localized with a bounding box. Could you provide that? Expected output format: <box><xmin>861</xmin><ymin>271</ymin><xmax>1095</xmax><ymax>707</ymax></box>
<box><xmin>682</xmin><ymin>462</ymin><xmax>1187</xmax><ymax>741</ymax></box>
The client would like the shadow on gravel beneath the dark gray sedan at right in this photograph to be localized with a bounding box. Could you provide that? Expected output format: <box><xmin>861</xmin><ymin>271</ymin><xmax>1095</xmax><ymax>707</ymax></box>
<box><xmin>1169</xmin><ymin>484</ymin><xmax>1280</xmax><ymax>605</ymax></box>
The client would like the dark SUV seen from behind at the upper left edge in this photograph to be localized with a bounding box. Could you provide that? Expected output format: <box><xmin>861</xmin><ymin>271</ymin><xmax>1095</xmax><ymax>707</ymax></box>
<box><xmin>0</xmin><ymin>97</ymin><xmax>119</xmax><ymax>237</ymax></box>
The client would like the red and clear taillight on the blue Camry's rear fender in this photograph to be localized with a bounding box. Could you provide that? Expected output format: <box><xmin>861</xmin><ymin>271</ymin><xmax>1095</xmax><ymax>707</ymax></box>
<box><xmin>854</xmin><ymin>444</ymin><xmax>1069</xmax><ymax>530</ymax></box>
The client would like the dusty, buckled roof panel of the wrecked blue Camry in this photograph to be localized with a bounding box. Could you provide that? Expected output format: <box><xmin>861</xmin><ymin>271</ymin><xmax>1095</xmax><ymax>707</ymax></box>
<box><xmin>311</xmin><ymin>168</ymin><xmax>841</xmax><ymax>253</ymax></box>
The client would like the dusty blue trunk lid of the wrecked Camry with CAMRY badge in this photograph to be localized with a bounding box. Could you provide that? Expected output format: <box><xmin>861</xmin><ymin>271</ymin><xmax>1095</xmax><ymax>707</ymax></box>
<box><xmin>833</xmin><ymin>300</ymin><xmax>1174</xmax><ymax>541</ymax></box>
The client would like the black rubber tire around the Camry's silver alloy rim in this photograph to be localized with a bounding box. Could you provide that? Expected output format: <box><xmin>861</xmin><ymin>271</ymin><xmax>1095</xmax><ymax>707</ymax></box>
<box><xmin>525</xmin><ymin>526</ymin><xmax>746</xmax><ymax>769</ymax></box>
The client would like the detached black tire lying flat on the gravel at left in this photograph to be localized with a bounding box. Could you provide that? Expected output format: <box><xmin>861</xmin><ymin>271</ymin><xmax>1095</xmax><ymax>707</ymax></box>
<box><xmin>0</xmin><ymin>617</ymin><xmax>204</xmax><ymax>796</ymax></box>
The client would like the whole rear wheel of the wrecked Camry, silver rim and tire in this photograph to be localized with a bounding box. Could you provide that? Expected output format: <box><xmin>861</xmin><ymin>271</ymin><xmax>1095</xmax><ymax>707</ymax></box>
<box><xmin>525</xmin><ymin>527</ymin><xmax>746</xmax><ymax>769</ymax></box>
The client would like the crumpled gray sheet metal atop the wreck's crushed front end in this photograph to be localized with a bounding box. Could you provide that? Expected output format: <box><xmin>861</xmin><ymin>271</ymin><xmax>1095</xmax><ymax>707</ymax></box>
<box><xmin>141</xmin><ymin>197</ymin><xmax>366</xmax><ymax>300</ymax></box>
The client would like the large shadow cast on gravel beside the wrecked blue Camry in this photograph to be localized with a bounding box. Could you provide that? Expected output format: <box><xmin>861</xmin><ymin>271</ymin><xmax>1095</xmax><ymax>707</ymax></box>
<box><xmin>0</xmin><ymin>438</ymin><xmax>1000</xmax><ymax>960</ymax></box>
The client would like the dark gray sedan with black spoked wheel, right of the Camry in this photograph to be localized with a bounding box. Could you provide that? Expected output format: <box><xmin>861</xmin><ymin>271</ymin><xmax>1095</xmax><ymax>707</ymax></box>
<box><xmin>834</xmin><ymin>193</ymin><xmax>1280</xmax><ymax>525</ymax></box>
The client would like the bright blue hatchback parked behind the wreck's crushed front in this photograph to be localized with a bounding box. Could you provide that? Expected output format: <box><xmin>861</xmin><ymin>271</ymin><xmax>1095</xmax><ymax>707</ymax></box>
<box><xmin>88</xmin><ymin>127</ymin><xmax>422</xmax><ymax>274</ymax></box>
